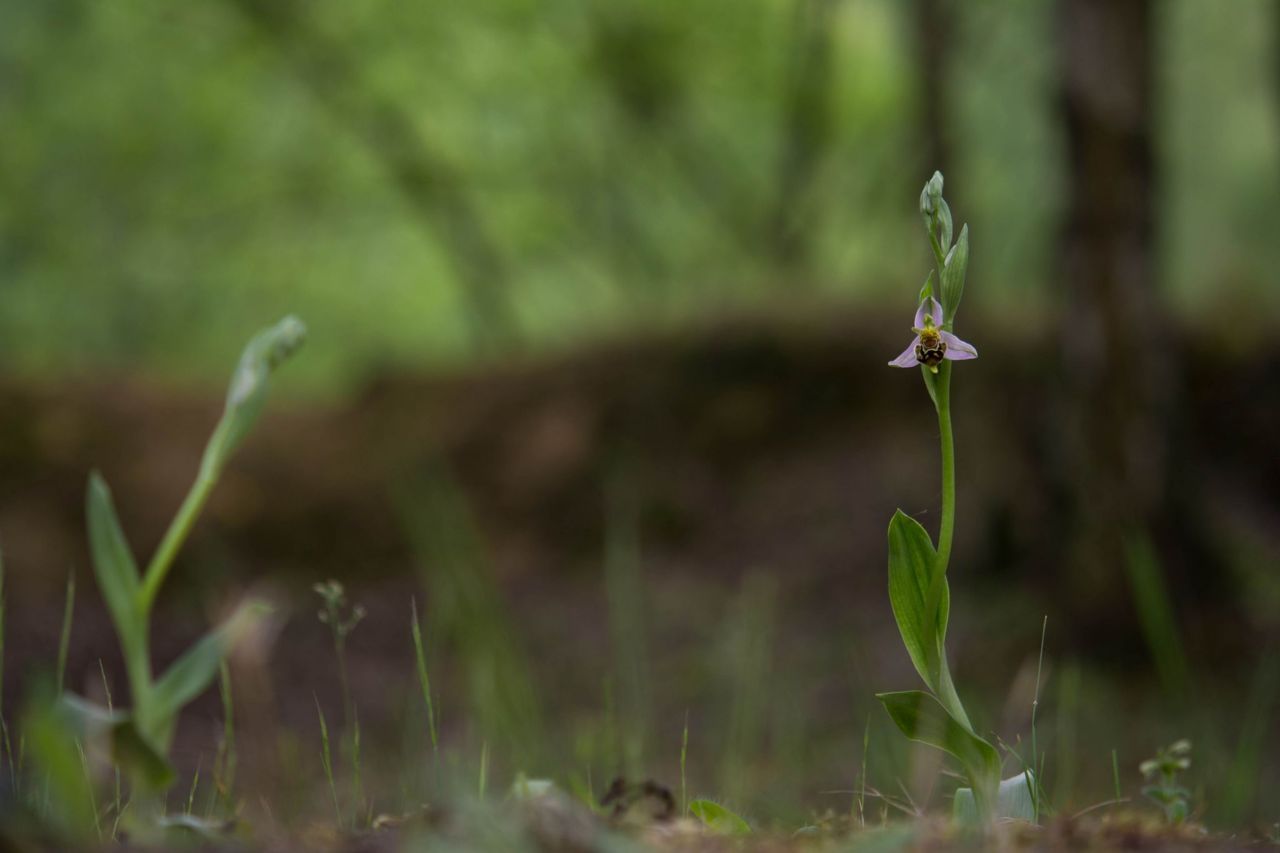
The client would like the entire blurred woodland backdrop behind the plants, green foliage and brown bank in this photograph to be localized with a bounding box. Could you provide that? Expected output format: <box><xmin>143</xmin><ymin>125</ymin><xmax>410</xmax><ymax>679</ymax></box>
<box><xmin>0</xmin><ymin>0</ymin><xmax>1280</xmax><ymax>826</ymax></box>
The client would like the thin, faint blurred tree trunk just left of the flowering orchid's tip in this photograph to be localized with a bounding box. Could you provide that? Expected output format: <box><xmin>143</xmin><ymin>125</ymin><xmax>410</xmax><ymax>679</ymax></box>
<box><xmin>768</xmin><ymin>0</ymin><xmax>836</xmax><ymax>269</ymax></box>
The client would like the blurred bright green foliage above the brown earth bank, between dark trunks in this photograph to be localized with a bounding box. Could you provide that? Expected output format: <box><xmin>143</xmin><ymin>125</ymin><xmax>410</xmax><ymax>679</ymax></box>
<box><xmin>0</xmin><ymin>0</ymin><xmax>1280</xmax><ymax>392</ymax></box>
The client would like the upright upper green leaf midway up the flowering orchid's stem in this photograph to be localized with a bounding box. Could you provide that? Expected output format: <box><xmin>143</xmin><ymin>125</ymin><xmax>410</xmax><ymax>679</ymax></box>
<box><xmin>888</xmin><ymin>510</ymin><xmax>951</xmax><ymax>690</ymax></box>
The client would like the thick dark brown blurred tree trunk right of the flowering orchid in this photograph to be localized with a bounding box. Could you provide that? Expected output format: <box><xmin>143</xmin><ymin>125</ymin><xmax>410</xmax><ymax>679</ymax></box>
<box><xmin>1049</xmin><ymin>0</ymin><xmax>1176</xmax><ymax>638</ymax></box>
